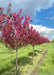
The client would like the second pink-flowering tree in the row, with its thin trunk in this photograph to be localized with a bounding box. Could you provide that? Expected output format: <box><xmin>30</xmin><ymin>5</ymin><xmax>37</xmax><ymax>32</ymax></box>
<box><xmin>26</xmin><ymin>26</ymin><xmax>40</xmax><ymax>63</ymax></box>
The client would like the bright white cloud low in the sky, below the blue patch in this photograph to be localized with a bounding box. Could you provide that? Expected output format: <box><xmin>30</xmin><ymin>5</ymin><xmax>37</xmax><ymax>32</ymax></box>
<box><xmin>30</xmin><ymin>24</ymin><xmax>54</xmax><ymax>40</ymax></box>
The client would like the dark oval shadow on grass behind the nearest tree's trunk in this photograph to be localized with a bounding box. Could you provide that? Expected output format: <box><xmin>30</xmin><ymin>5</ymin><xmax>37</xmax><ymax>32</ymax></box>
<box><xmin>11</xmin><ymin>57</ymin><xmax>32</xmax><ymax>66</ymax></box>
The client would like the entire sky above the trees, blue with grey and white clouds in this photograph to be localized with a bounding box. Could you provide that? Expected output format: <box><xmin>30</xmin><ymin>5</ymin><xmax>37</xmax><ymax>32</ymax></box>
<box><xmin>0</xmin><ymin>0</ymin><xmax>54</xmax><ymax>40</ymax></box>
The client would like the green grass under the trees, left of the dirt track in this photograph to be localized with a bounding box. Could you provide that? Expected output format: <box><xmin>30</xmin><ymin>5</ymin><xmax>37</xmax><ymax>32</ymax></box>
<box><xmin>0</xmin><ymin>43</ymin><xmax>47</xmax><ymax>75</ymax></box>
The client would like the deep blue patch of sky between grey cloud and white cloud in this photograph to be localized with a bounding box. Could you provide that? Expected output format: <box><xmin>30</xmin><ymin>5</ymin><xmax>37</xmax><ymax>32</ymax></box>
<box><xmin>32</xmin><ymin>4</ymin><xmax>54</xmax><ymax>28</ymax></box>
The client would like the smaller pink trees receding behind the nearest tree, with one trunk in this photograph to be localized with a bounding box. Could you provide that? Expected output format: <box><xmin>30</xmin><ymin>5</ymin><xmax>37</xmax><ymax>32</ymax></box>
<box><xmin>26</xmin><ymin>26</ymin><xmax>49</xmax><ymax>63</ymax></box>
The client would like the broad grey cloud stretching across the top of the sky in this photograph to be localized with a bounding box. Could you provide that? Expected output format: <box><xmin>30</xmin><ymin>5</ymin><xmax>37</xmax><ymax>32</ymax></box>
<box><xmin>0</xmin><ymin>0</ymin><xmax>54</xmax><ymax>17</ymax></box>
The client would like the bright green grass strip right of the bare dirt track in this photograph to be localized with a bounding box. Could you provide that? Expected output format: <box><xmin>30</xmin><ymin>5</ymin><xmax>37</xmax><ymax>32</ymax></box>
<box><xmin>38</xmin><ymin>43</ymin><xmax>54</xmax><ymax>75</ymax></box>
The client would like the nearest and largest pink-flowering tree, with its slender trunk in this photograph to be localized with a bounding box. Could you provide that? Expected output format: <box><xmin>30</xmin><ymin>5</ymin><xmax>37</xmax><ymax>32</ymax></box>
<box><xmin>2</xmin><ymin>9</ymin><xmax>32</xmax><ymax>75</ymax></box>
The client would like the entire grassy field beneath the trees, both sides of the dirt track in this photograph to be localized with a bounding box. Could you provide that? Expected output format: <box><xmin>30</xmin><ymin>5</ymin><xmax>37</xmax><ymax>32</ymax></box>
<box><xmin>0</xmin><ymin>43</ymin><xmax>54</xmax><ymax>75</ymax></box>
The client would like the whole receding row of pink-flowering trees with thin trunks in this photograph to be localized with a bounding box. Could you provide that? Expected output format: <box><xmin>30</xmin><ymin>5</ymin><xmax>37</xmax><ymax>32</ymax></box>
<box><xmin>0</xmin><ymin>8</ymin><xmax>50</xmax><ymax>75</ymax></box>
